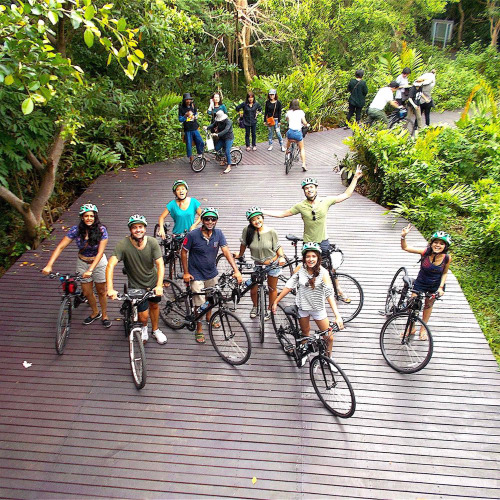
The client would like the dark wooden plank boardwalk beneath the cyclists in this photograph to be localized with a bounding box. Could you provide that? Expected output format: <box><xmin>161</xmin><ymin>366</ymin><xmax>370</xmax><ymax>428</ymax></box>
<box><xmin>0</xmin><ymin>115</ymin><xmax>500</xmax><ymax>499</ymax></box>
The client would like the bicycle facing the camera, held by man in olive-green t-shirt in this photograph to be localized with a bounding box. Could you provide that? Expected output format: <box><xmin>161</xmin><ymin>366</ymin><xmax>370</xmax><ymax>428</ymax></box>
<box><xmin>117</xmin><ymin>285</ymin><xmax>155</xmax><ymax>390</ymax></box>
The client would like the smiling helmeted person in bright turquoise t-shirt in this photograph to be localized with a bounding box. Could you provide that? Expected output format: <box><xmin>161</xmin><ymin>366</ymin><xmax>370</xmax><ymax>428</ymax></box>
<box><xmin>158</xmin><ymin>179</ymin><xmax>201</xmax><ymax>239</ymax></box>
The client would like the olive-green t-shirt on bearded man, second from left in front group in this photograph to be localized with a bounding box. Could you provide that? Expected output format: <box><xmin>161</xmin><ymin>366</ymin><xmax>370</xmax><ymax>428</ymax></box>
<box><xmin>113</xmin><ymin>236</ymin><xmax>161</xmax><ymax>288</ymax></box>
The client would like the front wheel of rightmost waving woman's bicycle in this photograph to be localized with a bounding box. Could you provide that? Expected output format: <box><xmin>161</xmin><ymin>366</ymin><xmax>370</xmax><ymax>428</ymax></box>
<box><xmin>380</xmin><ymin>312</ymin><xmax>433</xmax><ymax>373</ymax></box>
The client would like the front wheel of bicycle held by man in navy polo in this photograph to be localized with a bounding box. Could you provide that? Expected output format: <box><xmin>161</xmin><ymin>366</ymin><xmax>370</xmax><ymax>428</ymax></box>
<box><xmin>208</xmin><ymin>309</ymin><xmax>252</xmax><ymax>365</ymax></box>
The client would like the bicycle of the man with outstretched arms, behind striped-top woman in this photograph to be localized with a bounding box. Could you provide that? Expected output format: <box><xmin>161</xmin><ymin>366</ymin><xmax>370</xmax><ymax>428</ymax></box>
<box><xmin>279</xmin><ymin>234</ymin><xmax>364</xmax><ymax>323</ymax></box>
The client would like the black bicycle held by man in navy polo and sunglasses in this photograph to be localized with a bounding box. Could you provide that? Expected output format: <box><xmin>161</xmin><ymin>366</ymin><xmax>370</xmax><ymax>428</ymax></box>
<box><xmin>160</xmin><ymin>275</ymin><xmax>252</xmax><ymax>365</ymax></box>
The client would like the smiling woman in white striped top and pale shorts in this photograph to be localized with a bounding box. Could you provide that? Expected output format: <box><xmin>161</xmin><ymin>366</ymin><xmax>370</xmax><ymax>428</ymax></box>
<box><xmin>272</xmin><ymin>241</ymin><xmax>344</xmax><ymax>365</ymax></box>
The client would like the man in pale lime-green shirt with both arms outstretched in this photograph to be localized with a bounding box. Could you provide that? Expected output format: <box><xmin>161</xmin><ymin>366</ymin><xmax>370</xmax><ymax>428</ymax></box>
<box><xmin>264</xmin><ymin>167</ymin><xmax>363</xmax><ymax>252</ymax></box>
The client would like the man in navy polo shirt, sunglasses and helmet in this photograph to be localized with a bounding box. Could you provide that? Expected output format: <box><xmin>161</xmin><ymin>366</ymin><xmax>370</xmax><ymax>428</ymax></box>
<box><xmin>181</xmin><ymin>207</ymin><xmax>241</xmax><ymax>344</ymax></box>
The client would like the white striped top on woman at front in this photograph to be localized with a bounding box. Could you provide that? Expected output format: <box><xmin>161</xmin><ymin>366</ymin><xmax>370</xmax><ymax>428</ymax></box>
<box><xmin>285</xmin><ymin>266</ymin><xmax>333</xmax><ymax>311</ymax></box>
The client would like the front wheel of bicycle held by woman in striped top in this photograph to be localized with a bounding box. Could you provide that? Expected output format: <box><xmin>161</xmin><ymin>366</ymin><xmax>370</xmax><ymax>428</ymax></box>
<box><xmin>309</xmin><ymin>354</ymin><xmax>356</xmax><ymax>418</ymax></box>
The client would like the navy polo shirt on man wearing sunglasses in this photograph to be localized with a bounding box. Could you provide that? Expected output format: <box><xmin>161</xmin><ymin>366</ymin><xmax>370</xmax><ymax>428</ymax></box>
<box><xmin>183</xmin><ymin>227</ymin><xmax>227</xmax><ymax>281</ymax></box>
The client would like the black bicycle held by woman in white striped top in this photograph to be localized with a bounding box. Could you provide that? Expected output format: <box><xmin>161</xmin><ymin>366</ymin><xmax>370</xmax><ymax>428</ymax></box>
<box><xmin>271</xmin><ymin>304</ymin><xmax>356</xmax><ymax>418</ymax></box>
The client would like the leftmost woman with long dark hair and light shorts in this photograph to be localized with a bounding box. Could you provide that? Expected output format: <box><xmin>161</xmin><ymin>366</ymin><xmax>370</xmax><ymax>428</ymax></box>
<box><xmin>42</xmin><ymin>203</ymin><xmax>111</xmax><ymax>328</ymax></box>
